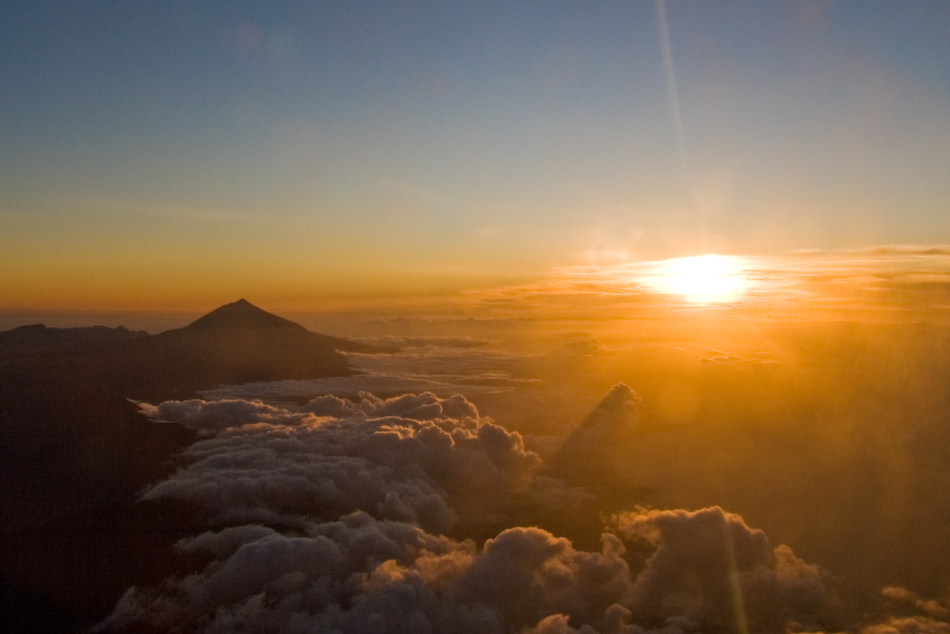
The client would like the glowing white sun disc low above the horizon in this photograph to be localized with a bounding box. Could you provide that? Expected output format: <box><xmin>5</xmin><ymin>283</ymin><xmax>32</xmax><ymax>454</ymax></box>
<box><xmin>642</xmin><ymin>253</ymin><xmax>749</xmax><ymax>304</ymax></box>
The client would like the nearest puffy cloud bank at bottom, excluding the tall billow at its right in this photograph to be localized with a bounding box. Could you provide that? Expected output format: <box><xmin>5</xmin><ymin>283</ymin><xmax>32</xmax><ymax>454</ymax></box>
<box><xmin>102</xmin><ymin>513</ymin><xmax>631</xmax><ymax>633</ymax></box>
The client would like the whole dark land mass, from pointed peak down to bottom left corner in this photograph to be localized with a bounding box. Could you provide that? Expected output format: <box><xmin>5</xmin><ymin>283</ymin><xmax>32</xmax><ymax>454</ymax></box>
<box><xmin>0</xmin><ymin>299</ymin><xmax>395</xmax><ymax>631</ymax></box>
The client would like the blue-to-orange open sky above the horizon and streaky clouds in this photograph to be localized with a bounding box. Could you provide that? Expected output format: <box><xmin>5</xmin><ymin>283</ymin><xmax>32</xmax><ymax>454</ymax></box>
<box><xmin>0</xmin><ymin>0</ymin><xmax>950</xmax><ymax>310</ymax></box>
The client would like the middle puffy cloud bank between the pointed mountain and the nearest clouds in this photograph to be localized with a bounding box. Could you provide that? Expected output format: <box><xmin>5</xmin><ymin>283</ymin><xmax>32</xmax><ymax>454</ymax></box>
<box><xmin>141</xmin><ymin>393</ymin><xmax>547</xmax><ymax>531</ymax></box>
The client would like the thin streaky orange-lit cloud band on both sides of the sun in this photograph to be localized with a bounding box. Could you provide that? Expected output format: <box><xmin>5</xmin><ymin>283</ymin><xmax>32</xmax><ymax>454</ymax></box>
<box><xmin>463</xmin><ymin>245</ymin><xmax>950</xmax><ymax>319</ymax></box>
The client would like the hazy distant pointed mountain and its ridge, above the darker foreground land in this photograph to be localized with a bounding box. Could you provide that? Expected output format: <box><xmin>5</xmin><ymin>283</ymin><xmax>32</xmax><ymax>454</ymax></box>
<box><xmin>0</xmin><ymin>299</ymin><xmax>394</xmax><ymax>400</ymax></box>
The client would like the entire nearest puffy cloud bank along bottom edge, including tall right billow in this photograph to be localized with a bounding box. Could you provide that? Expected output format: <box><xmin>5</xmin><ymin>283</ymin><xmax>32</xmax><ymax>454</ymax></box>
<box><xmin>102</xmin><ymin>509</ymin><xmax>840</xmax><ymax>634</ymax></box>
